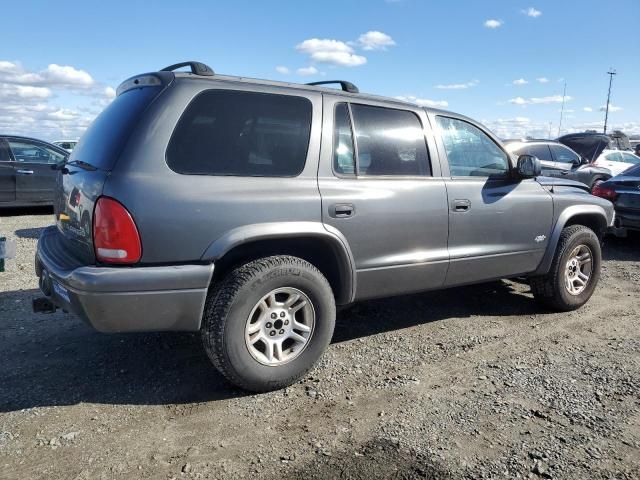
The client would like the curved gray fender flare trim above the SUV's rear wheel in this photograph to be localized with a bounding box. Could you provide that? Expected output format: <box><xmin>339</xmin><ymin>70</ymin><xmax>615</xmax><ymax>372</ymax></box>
<box><xmin>201</xmin><ymin>222</ymin><xmax>356</xmax><ymax>303</ymax></box>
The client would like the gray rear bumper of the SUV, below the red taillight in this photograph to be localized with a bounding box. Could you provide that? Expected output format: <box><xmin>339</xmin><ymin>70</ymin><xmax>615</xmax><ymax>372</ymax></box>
<box><xmin>36</xmin><ymin>227</ymin><xmax>214</xmax><ymax>332</ymax></box>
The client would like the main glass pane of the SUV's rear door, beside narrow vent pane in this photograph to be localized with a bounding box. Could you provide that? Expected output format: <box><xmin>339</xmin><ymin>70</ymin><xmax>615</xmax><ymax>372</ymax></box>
<box><xmin>351</xmin><ymin>104</ymin><xmax>431</xmax><ymax>176</ymax></box>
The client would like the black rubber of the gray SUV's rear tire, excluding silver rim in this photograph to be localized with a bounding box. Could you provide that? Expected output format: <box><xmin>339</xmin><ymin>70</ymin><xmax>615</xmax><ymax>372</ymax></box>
<box><xmin>201</xmin><ymin>256</ymin><xmax>336</xmax><ymax>392</ymax></box>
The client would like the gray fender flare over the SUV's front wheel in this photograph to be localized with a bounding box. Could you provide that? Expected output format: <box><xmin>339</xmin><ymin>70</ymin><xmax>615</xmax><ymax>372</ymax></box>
<box><xmin>534</xmin><ymin>205</ymin><xmax>609</xmax><ymax>275</ymax></box>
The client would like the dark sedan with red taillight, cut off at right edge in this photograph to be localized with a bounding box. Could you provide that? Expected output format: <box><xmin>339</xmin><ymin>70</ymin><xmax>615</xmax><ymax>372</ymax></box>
<box><xmin>593</xmin><ymin>165</ymin><xmax>640</xmax><ymax>235</ymax></box>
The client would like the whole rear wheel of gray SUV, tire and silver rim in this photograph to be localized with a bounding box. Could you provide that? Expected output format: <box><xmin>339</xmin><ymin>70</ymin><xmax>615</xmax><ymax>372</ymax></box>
<box><xmin>201</xmin><ymin>256</ymin><xmax>336</xmax><ymax>392</ymax></box>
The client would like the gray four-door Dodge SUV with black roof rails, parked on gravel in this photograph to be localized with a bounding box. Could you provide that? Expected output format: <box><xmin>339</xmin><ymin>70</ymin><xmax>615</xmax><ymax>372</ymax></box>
<box><xmin>34</xmin><ymin>62</ymin><xmax>614</xmax><ymax>391</ymax></box>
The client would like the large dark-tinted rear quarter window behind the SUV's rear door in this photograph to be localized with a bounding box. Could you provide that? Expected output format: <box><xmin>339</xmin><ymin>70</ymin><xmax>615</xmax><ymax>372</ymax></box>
<box><xmin>167</xmin><ymin>90</ymin><xmax>311</xmax><ymax>177</ymax></box>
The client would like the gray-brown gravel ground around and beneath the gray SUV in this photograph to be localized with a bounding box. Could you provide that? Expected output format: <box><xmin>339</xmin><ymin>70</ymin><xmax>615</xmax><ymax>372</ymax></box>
<box><xmin>0</xmin><ymin>210</ymin><xmax>640</xmax><ymax>480</ymax></box>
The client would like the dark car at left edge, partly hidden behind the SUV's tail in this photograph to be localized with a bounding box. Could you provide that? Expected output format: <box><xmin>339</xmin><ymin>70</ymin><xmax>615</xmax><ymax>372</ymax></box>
<box><xmin>0</xmin><ymin>135</ymin><xmax>69</xmax><ymax>208</ymax></box>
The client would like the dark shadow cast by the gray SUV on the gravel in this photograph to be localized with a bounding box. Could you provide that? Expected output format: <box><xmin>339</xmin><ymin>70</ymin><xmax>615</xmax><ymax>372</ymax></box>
<box><xmin>0</xmin><ymin>282</ymin><xmax>539</xmax><ymax>412</ymax></box>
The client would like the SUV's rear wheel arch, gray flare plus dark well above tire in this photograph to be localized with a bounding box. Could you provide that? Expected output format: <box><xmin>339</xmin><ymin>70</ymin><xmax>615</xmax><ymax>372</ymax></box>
<box><xmin>201</xmin><ymin>222</ymin><xmax>356</xmax><ymax>305</ymax></box>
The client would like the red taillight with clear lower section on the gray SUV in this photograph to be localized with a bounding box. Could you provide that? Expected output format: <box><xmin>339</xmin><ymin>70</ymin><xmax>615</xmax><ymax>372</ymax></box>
<box><xmin>93</xmin><ymin>197</ymin><xmax>142</xmax><ymax>263</ymax></box>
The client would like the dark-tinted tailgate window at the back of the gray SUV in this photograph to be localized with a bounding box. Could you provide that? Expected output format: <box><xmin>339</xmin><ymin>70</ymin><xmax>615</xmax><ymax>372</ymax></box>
<box><xmin>70</xmin><ymin>87</ymin><xmax>162</xmax><ymax>170</ymax></box>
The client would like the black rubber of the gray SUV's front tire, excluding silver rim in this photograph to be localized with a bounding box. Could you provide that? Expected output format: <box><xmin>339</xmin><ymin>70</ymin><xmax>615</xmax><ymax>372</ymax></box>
<box><xmin>529</xmin><ymin>225</ymin><xmax>602</xmax><ymax>312</ymax></box>
